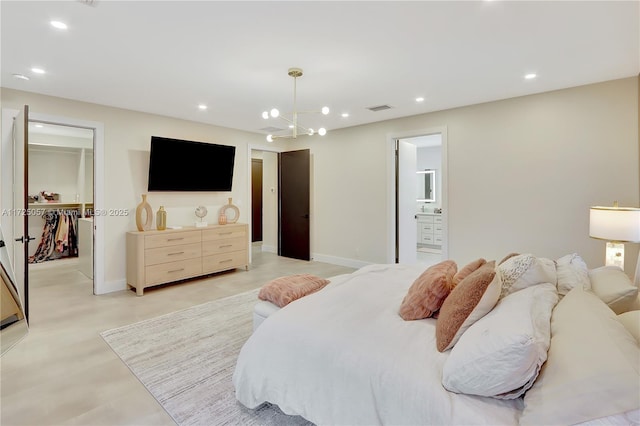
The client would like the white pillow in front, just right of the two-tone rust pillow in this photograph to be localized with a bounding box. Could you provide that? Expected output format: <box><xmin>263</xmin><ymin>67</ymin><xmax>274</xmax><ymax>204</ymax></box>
<box><xmin>442</xmin><ymin>283</ymin><xmax>558</xmax><ymax>399</ymax></box>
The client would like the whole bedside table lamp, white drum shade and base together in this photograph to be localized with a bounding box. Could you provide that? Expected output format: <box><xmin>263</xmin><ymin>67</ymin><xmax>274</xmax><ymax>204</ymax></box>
<box><xmin>589</xmin><ymin>201</ymin><xmax>640</xmax><ymax>269</ymax></box>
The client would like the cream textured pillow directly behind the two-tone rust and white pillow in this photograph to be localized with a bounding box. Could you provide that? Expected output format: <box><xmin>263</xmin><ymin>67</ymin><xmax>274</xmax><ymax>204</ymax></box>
<box><xmin>498</xmin><ymin>254</ymin><xmax>558</xmax><ymax>299</ymax></box>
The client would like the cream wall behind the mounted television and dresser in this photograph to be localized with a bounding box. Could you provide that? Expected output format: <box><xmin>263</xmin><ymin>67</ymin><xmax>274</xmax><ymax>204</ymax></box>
<box><xmin>1</xmin><ymin>88</ymin><xmax>284</xmax><ymax>289</ymax></box>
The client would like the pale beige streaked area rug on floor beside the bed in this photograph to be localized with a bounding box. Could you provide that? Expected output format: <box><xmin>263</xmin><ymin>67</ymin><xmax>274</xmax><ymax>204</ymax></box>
<box><xmin>100</xmin><ymin>290</ymin><xmax>311</xmax><ymax>426</ymax></box>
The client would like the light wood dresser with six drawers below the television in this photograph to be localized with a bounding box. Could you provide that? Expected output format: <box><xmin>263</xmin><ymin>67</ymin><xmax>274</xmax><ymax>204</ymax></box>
<box><xmin>127</xmin><ymin>223</ymin><xmax>249</xmax><ymax>296</ymax></box>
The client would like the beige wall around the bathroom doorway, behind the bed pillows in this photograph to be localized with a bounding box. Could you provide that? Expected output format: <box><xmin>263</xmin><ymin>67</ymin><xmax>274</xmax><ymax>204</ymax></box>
<box><xmin>297</xmin><ymin>77</ymin><xmax>640</xmax><ymax>275</ymax></box>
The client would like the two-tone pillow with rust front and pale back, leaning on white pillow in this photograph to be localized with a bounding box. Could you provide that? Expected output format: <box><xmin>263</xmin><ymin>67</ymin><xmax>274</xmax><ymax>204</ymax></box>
<box><xmin>436</xmin><ymin>261</ymin><xmax>502</xmax><ymax>352</ymax></box>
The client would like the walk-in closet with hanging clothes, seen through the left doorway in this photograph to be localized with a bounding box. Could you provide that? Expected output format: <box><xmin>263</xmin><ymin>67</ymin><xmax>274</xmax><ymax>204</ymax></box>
<box><xmin>27</xmin><ymin>123</ymin><xmax>93</xmax><ymax>280</ymax></box>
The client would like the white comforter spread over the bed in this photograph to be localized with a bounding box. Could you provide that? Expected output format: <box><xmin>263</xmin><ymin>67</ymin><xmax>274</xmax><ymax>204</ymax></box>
<box><xmin>233</xmin><ymin>265</ymin><xmax>523</xmax><ymax>425</ymax></box>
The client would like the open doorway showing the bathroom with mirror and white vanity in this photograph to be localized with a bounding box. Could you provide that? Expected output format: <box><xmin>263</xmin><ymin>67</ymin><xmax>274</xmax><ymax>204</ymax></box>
<box><xmin>388</xmin><ymin>128</ymin><xmax>448</xmax><ymax>264</ymax></box>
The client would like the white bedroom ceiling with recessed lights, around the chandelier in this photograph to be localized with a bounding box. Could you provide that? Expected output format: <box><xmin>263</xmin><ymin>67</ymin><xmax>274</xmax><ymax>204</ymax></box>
<box><xmin>0</xmin><ymin>0</ymin><xmax>640</xmax><ymax>140</ymax></box>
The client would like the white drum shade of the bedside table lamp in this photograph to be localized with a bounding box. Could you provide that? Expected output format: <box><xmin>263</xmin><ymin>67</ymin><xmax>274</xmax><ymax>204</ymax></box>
<box><xmin>589</xmin><ymin>207</ymin><xmax>640</xmax><ymax>243</ymax></box>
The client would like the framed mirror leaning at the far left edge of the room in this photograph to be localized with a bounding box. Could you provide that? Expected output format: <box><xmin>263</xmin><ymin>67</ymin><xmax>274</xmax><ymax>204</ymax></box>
<box><xmin>0</xmin><ymin>228</ymin><xmax>29</xmax><ymax>355</ymax></box>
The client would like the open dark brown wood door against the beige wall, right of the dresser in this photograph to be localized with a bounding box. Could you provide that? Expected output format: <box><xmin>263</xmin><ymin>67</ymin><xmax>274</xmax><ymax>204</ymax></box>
<box><xmin>278</xmin><ymin>149</ymin><xmax>311</xmax><ymax>260</ymax></box>
